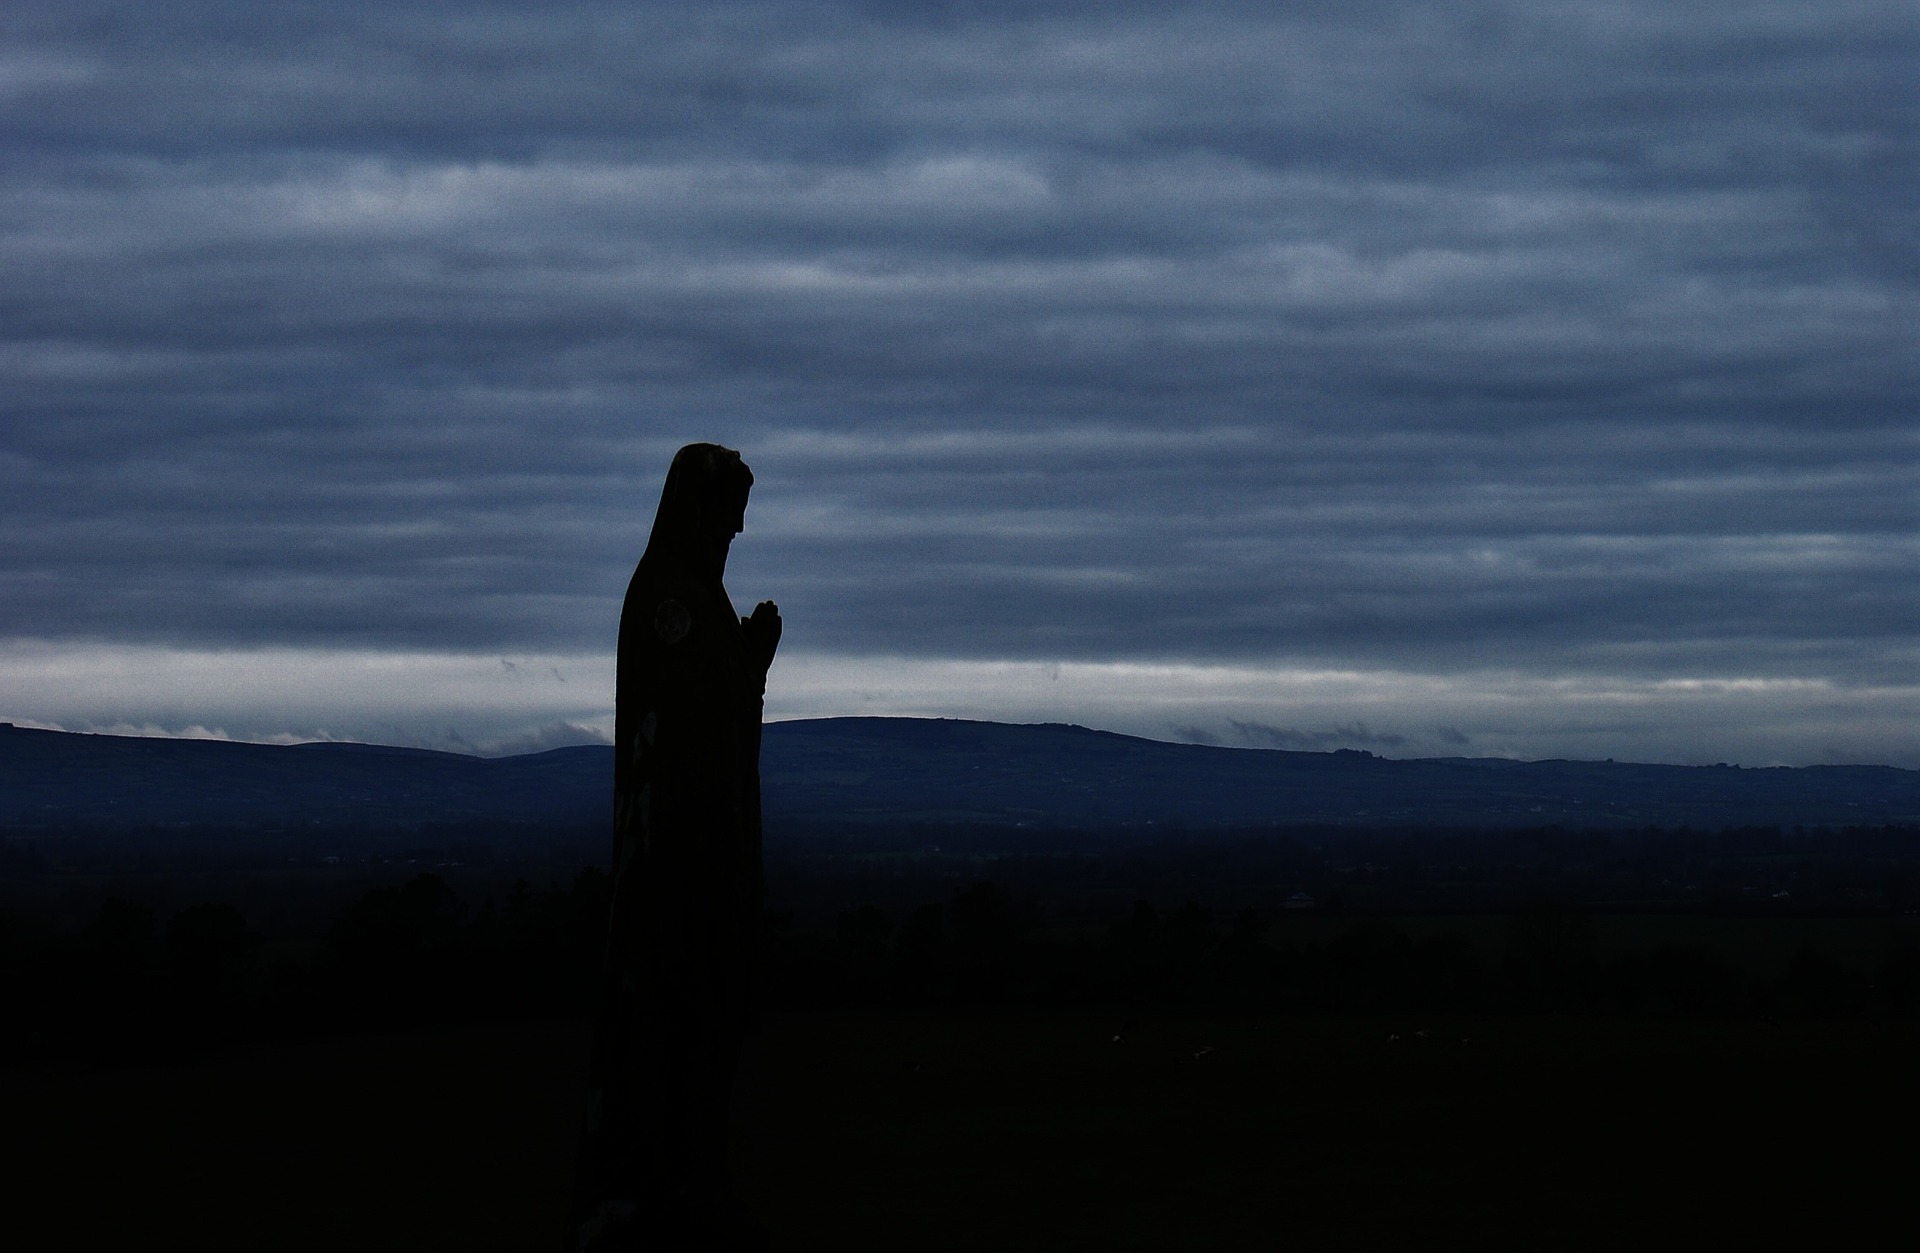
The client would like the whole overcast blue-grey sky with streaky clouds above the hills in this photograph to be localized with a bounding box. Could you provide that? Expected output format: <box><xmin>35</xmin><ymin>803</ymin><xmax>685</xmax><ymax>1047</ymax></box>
<box><xmin>0</xmin><ymin>0</ymin><xmax>1920</xmax><ymax>766</ymax></box>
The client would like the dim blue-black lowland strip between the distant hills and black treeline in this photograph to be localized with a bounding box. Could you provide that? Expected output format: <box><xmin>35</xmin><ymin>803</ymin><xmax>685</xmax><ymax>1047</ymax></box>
<box><xmin>0</xmin><ymin>821</ymin><xmax>1920</xmax><ymax>913</ymax></box>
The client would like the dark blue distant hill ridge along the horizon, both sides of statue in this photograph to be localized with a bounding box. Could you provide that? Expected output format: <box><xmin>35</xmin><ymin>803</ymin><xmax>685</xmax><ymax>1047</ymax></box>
<box><xmin>0</xmin><ymin>718</ymin><xmax>1920</xmax><ymax>837</ymax></box>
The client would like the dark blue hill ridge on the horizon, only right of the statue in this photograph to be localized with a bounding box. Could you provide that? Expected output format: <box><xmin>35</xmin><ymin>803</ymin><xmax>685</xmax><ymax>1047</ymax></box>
<box><xmin>762</xmin><ymin>718</ymin><xmax>1920</xmax><ymax>827</ymax></box>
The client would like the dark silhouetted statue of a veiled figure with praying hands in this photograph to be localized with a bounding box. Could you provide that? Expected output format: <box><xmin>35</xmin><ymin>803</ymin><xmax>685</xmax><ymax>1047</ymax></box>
<box><xmin>568</xmin><ymin>443</ymin><xmax>780</xmax><ymax>1253</ymax></box>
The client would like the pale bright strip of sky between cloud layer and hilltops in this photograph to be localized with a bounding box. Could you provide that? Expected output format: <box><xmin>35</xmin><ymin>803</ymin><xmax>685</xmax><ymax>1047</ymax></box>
<box><xmin>0</xmin><ymin>643</ymin><xmax>1920</xmax><ymax>768</ymax></box>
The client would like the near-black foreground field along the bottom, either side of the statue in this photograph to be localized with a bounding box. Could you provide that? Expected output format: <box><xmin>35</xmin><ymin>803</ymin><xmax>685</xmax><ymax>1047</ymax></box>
<box><xmin>0</xmin><ymin>1013</ymin><xmax>1920</xmax><ymax>1253</ymax></box>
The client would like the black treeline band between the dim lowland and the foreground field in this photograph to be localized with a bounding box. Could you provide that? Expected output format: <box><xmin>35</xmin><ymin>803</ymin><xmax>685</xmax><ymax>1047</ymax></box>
<box><xmin>0</xmin><ymin>865</ymin><xmax>1920</xmax><ymax>1065</ymax></box>
